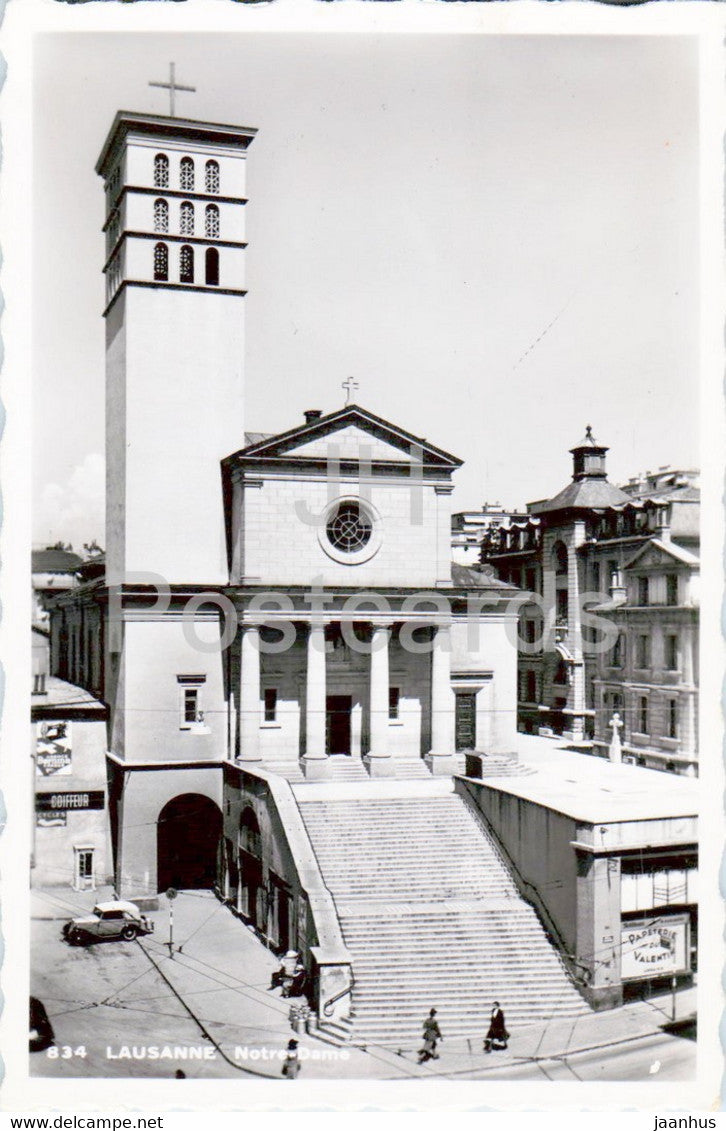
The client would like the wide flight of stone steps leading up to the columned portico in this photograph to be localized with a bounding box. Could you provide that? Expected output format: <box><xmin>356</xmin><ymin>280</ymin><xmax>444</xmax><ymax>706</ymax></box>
<box><xmin>295</xmin><ymin>782</ymin><xmax>589</xmax><ymax>1050</ymax></box>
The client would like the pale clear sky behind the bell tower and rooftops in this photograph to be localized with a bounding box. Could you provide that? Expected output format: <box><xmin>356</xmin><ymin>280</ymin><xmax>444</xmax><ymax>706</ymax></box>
<box><xmin>33</xmin><ymin>33</ymin><xmax>700</xmax><ymax>549</ymax></box>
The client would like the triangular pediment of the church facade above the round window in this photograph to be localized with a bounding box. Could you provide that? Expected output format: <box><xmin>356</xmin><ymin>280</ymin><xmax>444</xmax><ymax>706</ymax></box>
<box><xmin>231</xmin><ymin>405</ymin><xmax>461</xmax><ymax>469</ymax></box>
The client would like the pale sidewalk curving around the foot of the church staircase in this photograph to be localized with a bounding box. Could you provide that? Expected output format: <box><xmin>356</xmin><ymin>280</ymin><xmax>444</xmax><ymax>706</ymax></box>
<box><xmin>132</xmin><ymin>891</ymin><xmax>695</xmax><ymax>1079</ymax></box>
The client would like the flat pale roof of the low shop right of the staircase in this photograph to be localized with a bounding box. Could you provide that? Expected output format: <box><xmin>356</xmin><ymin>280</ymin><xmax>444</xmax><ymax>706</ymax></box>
<box><xmin>479</xmin><ymin>734</ymin><xmax>699</xmax><ymax>823</ymax></box>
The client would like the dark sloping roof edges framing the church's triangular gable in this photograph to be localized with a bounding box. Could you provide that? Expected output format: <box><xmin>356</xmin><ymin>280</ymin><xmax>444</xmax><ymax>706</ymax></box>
<box><xmin>222</xmin><ymin>405</ymin><xmax>463</xmax><ymax>468</ymax></box>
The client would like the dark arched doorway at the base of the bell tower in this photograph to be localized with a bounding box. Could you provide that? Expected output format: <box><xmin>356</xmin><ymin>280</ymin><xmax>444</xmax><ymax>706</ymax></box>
<box><xmin>156</xmin><ymin>793</ymin><xmax>222</xmax><ymax>891</ymax></box>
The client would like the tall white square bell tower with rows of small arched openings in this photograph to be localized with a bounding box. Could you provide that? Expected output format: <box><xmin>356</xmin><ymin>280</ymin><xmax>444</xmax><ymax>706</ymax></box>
<box><xmin>96</xmin><ymin>111</ymin><xmax>257</xmax><ymax>586</ymax></box>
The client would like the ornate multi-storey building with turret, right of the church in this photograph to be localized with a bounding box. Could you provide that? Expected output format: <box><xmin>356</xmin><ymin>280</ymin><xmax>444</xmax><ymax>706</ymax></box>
<box><xmin>474</xmin><ymin>428</ymin><xmax>699</xmax><ymax>775</ymax></box>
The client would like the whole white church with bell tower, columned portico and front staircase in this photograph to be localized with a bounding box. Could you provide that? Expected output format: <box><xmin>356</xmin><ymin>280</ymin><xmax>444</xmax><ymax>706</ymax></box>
<box><xmin>51</xmin><ymin>101</ymin><xmax>687</xmax><ymax>1043</ymax></box>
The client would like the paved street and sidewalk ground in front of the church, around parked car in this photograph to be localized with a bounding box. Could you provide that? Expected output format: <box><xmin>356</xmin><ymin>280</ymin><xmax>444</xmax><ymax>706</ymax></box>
<box><xmin>31</xmin><ymin>889</ymin><xmax>695</xmax><ymax>1081</ymax></box>
